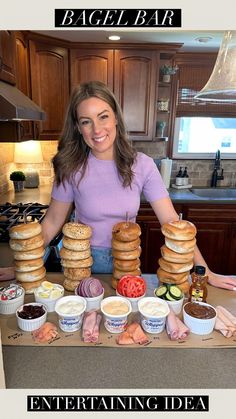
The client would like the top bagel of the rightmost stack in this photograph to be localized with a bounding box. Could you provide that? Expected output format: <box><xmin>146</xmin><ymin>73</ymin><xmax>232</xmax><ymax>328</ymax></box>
<box><xmin>161</xmin><ymin>220</ymin><xmax>197</xmax><ymax>240</ymax></box>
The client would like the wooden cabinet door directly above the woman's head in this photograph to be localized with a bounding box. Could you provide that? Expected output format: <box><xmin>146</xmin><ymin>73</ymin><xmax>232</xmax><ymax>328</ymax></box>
<box><xmin>70</xmin><ymin>48</ymin><xmax>114</xmax><ymax>90</ymax></box>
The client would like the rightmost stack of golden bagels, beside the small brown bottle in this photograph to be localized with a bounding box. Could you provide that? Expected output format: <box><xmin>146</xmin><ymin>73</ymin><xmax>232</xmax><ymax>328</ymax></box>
<box><xmin>157</xmin><ymin>220</ymin><xmax>197</xmax><ymax>294</ymax></box>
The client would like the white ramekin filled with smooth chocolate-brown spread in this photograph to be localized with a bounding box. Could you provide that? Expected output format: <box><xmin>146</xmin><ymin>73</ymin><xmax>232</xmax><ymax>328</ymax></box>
<box><xmin>183</xmin><ymin>302</ymin><xmax>216</xmax><ymax>335</ymax></box>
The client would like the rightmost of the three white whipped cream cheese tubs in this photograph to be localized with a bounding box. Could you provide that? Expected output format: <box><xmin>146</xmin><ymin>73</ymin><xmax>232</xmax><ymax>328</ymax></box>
<box><xmin>138</xmin><ymin>297</ymin><xmax>170</xmax><ymax>333</ymax></box>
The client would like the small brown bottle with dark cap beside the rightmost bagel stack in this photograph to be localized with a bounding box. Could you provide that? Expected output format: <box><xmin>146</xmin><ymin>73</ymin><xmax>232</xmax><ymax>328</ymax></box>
<box><xmin>188</xmin><ymin>265</ymin><xmax>208</xmax><ymax>303</ymax></box>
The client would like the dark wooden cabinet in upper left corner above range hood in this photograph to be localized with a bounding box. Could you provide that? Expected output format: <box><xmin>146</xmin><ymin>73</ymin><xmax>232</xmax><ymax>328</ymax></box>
<box><xmin>0</xmin><ymin>31</ymin><xmax>16</xmax><ymax>84</ymax></box>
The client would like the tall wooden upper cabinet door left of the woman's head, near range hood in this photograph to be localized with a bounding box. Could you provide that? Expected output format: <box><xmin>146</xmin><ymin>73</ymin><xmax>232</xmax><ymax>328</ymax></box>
<box><xmin>29</xmin><ymin>40</ymin><xmax>69</xmax><ymax>140</ymax></box>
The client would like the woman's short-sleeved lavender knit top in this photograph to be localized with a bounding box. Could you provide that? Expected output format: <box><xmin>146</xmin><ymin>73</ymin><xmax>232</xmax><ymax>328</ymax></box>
<box><xmin>52</xmin><ymin>153</ymin><xmax>168</xmax><ymax>247</ymax></box>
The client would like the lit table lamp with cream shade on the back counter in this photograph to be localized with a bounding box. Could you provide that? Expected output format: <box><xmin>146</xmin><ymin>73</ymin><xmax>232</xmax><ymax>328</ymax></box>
<box><xmin>14</xmin><ymin>140</ymin><xmax>43</xmax><ymax>188</ymax></box>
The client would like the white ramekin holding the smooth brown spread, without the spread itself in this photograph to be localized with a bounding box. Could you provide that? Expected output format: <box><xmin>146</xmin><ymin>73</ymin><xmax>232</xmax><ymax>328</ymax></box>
<box><xmin>183</xmin><ymin>302</ymin><xmax>216</xmax><ymax>335</ymax></box>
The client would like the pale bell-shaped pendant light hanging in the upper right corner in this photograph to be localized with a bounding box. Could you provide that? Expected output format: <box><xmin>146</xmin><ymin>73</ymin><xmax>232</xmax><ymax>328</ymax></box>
<box><xmin>194</xmin><ymin>31</ymin><xmax>236</xmax><ymax>102</ymax></box>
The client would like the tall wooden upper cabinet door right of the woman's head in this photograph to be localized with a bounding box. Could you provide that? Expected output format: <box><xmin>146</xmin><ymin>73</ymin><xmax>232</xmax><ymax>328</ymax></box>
<box><xmin>114</xmin><ymin>49</ymin><xmax>157</xmax><ymax>141</ymax></box>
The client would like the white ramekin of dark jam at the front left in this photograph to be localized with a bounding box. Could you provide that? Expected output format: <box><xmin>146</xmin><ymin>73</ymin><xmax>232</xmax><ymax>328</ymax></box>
<box><xmin>16</xmin><ymin>303</ymin><xmax>47</xmax><ymax>332</ymax></box>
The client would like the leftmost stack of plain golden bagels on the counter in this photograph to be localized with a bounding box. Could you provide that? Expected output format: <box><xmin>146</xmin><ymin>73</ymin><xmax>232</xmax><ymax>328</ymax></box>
<box><xmin>9</xmin><ymin>221</ymin><xmax>46</xmax><ymax>294</ymax></box>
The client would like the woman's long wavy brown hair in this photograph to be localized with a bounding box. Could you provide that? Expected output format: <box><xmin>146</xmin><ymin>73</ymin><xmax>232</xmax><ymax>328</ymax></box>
<box><xmin>52</xmin><ymin>81</ymin><xmax>137</xmax><ymax>187</ymax></box>
